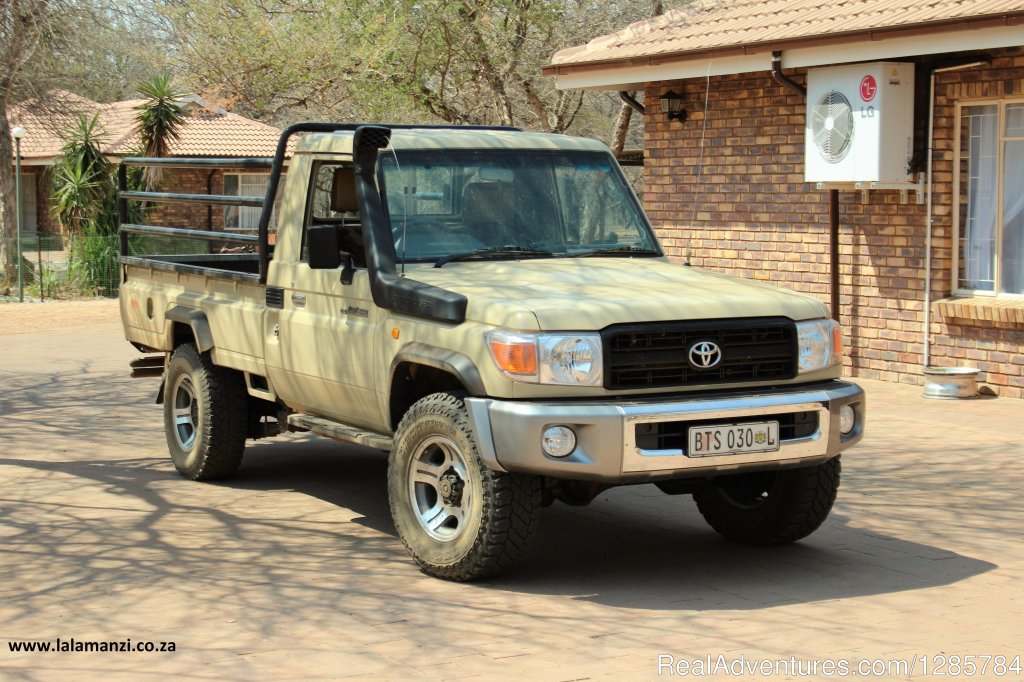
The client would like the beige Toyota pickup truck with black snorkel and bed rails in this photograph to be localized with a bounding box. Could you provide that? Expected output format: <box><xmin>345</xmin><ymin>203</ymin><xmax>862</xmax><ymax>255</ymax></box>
<box><xmin>120</xmin><ymin>123</ymin><xmax>865</xmax><ymax>581</ymax></box>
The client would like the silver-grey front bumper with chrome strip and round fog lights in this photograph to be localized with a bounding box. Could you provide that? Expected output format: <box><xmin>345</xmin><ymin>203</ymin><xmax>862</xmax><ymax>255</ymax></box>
<box><xmin>466</xmin><ymin>381</ymin><xmax>865</xmax><ymax>483</ymax></box>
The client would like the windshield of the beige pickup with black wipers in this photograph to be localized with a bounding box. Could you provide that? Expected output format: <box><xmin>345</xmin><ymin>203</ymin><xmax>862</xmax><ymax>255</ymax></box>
<box><xmin>380</xmin><ymin>150</ymin><xmax>660</xmax><ymax>264</ymax></box>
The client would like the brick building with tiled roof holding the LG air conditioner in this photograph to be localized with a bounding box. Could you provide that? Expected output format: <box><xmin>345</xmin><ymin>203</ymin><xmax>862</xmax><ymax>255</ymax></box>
<box><xmin>545</xmin><ymin>0</ymin><xmax>1024</xmax><ymax>397</ymax></box>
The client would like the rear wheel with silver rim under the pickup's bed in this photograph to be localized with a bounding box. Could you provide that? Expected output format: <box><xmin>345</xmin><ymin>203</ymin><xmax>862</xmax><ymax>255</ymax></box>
<box><xmin>164</xmin><ymin>343</ymin><xmax>249</xmax><ymax>480</ymax></box>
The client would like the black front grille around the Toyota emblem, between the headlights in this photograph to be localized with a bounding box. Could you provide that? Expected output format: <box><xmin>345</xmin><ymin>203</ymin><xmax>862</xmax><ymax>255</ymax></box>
<box><xmin>601</xmin><ymin>317</ymin><xmax>798</xmax><ymax>390</ymax></box>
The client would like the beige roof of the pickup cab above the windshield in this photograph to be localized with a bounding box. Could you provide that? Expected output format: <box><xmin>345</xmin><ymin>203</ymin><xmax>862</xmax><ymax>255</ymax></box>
<box><xmin>295</xmin><ymin>128</ymin><xmax>608</xmax><ymax>154</ymax></box>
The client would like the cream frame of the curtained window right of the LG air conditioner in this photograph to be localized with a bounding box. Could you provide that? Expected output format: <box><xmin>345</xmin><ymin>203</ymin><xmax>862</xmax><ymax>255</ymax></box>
<box><xmin>951</xmin><ymin>97</ymin><xmax>1024</xmax><ymax>300</ymax></box>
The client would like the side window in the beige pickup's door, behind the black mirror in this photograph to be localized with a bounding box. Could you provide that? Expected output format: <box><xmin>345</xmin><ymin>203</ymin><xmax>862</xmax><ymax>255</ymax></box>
<box><xmin>302</xmin><ymin>162</ymin><xmax>366</xmax><ymax>267</ymax></box>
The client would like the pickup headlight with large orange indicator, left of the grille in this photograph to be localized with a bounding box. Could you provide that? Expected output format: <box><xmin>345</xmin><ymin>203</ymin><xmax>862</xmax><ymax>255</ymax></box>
<box><xmin>484</xmin><ymin>331</ymin><xmax>604</xmax><ymax>386</ymax></box>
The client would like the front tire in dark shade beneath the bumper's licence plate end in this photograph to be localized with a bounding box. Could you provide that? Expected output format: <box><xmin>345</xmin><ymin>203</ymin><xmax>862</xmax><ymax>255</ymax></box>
<box><xmin>693</xmin><ymin>457</ymin><xmax>841</xmax><ymax>545</ymax></box>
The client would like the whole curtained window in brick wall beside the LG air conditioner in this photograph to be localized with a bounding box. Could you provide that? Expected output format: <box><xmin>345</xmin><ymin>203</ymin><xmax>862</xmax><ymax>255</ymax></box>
<box><xmin>953</xmin><ymin>100</ymin><xmax>1024</xmax><ymax>295</ymax></box>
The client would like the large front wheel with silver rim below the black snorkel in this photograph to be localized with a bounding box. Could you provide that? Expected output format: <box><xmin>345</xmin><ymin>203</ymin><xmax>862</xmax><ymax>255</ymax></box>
<box><xmin>387</xmin><ymin>393</ymin><xmax>542</xmax><ymax>581</ymax></box>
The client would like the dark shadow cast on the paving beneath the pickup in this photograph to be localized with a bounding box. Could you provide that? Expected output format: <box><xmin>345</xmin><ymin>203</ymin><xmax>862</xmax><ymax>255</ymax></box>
<box><xmin>227</xmin><ymin>438</ymin><xmax>995</xmax><ymax>609</ymax></box>
